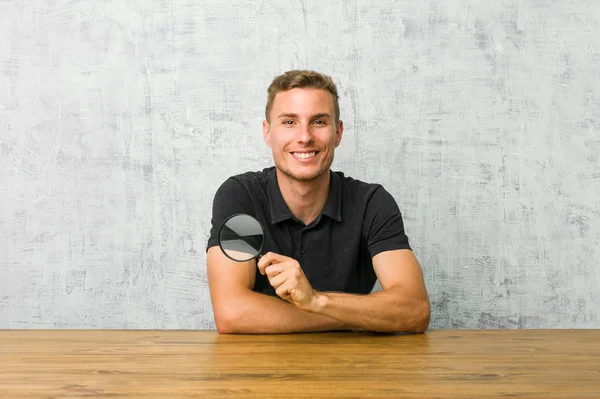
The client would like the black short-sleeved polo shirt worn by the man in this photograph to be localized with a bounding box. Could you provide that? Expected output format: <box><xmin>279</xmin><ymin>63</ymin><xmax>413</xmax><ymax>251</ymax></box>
<box><xmin>207</xmin><ymin>167</ymin><xmax>411</xmax><ymax>296</ymax></box>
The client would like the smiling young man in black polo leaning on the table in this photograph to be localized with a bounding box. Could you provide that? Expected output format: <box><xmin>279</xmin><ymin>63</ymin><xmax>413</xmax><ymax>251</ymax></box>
<box><xmin>207</xmin><ymin>70</ymin><xmax>430</xmax><ymax>333</ymax></box>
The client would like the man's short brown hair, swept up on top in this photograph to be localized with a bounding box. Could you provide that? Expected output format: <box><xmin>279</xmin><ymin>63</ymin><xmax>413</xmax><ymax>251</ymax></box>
<box><xmin>265</xmin><ymin>70</ymin><xmax>340</xmax><ymax>122</ymax></box>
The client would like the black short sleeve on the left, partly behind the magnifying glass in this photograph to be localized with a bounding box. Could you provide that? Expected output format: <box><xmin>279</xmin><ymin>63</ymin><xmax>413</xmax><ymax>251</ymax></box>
<box><xmin>206</xmin><ymin>177</ymin><xmax>253</xmax><ymax>250</ymax></box>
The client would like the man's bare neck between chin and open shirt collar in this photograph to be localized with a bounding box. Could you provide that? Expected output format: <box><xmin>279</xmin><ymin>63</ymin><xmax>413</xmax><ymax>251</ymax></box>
<box><xmin>276</xmin><ymin>169</ymin><xmax>330</xmax><ymax>225</ymax></box>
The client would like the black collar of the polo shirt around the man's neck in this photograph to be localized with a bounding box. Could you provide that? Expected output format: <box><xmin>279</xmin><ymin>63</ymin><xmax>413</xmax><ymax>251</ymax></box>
<box><xmin>267</xmin><ymin>167</ymin><xmax>342</xmax><ymax>224</ymax></box>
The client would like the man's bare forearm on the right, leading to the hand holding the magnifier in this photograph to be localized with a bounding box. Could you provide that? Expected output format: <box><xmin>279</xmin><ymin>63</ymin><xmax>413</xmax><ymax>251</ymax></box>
<box><xmin>311</xmin><ymin>288</ymin><xmax>430</xmax><ymax>332</ymax></box>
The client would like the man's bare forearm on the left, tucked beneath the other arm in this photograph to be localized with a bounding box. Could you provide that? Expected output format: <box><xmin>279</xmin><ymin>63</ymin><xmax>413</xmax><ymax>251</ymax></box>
<box><xmin>215</xmin><ymin>291</ymin><xmax>348</xmax><ymax>334</ymax></box>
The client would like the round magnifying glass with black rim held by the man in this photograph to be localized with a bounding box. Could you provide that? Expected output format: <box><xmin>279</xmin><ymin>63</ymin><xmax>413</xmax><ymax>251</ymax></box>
<box><xmin>219</xmin><ymin>213</ymin><xmax>265</xmax><ymax>262</ymax></box>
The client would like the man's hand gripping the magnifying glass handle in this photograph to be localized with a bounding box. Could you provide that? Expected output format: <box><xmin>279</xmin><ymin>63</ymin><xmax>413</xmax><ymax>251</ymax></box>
<box><xmin>258</xmin><ymin>252</ymin><xmax>318</xmax><ymax>312</ymax></box>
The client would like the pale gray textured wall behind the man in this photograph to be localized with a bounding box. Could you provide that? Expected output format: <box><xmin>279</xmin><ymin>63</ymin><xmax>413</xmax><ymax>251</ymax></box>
<box><xmin>0</xmin><ymin>0</ymin><xmax>600</xmax><ymax>329</ymax></box>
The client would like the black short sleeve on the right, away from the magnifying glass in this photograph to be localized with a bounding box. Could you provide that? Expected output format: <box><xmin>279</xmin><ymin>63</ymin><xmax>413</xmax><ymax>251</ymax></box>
<box><xmin>364</xmin><ymin>186</ymin><xmax>411</xmax><ymax>257</ymax></box>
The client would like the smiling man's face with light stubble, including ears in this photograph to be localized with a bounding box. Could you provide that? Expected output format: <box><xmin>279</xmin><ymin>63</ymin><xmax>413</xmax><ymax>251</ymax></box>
<box><xmin>263</xmin><ymin>89</ymin><xmax>344</xmax><ymax>181</ymax></box>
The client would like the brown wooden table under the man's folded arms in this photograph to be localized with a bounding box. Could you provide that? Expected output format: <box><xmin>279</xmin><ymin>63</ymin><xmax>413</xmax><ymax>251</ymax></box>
<box><xmin>0</xmin><ymin>330</ymin><xmax>600</xmax><ymax>399</ymax></box>
